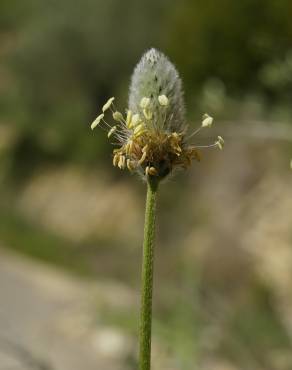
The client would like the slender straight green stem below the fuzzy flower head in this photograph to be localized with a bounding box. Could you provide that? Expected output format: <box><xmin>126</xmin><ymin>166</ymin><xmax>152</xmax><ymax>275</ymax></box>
<box><xmin>139</xmin><ymin>180</ymin><xmax>158</xmax><ymax>370</ymax></box>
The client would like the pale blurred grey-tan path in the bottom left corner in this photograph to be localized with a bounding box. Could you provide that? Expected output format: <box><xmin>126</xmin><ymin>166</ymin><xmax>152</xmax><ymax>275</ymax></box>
<box><xmin>0</xmin><ymin>248</ymin><xmax>133</xmax><ymax>370</ymax></box>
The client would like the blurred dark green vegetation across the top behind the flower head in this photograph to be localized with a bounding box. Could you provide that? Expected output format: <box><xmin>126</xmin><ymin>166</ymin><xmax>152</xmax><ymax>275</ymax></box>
<box><xmin>0</xmin><ymin>0</ymin><xmax>292</xmax><ymax>179</ymax></box>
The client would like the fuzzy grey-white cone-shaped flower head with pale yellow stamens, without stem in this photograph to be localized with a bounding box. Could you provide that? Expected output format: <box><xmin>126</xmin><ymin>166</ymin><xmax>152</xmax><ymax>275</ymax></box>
<box><xmin>91</xmin><ymin>49</ymin><xmax>224</xmax><ymax>180</ymax></box>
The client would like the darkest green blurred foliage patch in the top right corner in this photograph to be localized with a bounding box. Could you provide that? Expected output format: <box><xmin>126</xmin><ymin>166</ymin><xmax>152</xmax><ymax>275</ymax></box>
<box><xmin>167</xmin><ymin>0</ymin><xmax>292</xmax><ymax>99</ymax></box>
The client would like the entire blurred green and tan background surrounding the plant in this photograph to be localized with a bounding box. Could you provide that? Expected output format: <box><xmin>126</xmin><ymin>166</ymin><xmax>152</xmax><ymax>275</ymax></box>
<box><xmin>0</xmin><ymin>0</ymin><xmax>292</xmax><ymax>370</ymax></box>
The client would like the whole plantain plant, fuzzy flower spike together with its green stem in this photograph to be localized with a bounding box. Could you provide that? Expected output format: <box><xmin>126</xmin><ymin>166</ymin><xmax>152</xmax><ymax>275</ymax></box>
<box><xmin>91</xmin><ymin>49</ymin><xmax>224</xmax><ymax>370</ymax></box>
